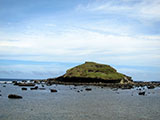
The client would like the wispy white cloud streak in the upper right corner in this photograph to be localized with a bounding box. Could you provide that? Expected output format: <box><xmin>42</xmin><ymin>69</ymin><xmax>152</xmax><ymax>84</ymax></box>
<box><xmin>76</xmin><ymin>0</ymin><xmax>160</xmax><ymax>21</ymax></box>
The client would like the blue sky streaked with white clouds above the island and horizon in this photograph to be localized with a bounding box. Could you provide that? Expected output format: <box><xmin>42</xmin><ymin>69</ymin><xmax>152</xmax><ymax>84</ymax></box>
<box><xmin>0</xmin><ymin>0</ymin><xmax>160</xmax><ymax>81</ymax></box>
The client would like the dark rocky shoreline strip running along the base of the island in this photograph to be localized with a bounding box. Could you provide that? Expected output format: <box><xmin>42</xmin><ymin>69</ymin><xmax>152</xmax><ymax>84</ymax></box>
<box><xmin>0</xmin><ymin>79</ymin><xmax>160</xmax><ymax>89</ymax></box>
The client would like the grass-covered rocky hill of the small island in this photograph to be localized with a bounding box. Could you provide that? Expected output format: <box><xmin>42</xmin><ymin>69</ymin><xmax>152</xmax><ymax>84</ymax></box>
<box><xmin>48</xmin><ymin>62</ymin><xmax>132</xmax><ymax>84</ymax></box>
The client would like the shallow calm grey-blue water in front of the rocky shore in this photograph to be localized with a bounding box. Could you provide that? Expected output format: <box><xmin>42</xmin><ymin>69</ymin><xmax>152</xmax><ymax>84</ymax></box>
<box><xmin>0</xmin><ymin>79</ymin><xmax>160</xmax><ymax>120</ymax></box>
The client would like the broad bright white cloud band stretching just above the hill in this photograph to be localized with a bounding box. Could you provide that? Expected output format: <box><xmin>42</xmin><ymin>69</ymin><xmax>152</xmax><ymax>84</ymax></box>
<box><xmin>0</xmin><ymin>27</ymin><xmax>160</xmax><ymax>65</ymax></box>
